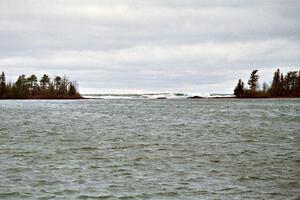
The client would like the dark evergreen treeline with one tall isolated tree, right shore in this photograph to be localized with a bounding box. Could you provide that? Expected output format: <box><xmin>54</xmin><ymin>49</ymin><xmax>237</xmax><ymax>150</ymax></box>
<box><xmin>234</xmin><ymin>69</ymin><xmax>300</xmax><ymax>98</ymax></box>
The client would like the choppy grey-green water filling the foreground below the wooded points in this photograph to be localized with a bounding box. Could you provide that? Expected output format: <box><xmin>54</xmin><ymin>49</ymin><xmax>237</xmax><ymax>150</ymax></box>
<box><xmin>0</xmin><ymin>99</ymin><xmax>300</xmax><ymax>199</ymax></box>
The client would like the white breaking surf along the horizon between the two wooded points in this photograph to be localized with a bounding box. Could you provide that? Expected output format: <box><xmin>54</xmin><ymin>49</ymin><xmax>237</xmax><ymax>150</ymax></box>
<box><xmin>82</xmin><ymin>93</ymin><xmax>233</xmax><ymax>99</ymax></box>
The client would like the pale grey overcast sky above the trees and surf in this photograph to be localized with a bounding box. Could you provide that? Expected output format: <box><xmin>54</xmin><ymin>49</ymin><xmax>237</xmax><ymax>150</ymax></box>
<box><xmin>0</xmin><ymin>0</ymin><xmax>300</xmax><ymax>94</ymax></box>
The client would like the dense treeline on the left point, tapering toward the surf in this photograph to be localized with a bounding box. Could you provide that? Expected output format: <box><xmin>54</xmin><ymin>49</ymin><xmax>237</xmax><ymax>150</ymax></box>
<box><xmin>0</xmin><ymin>72</ymin><xmax>81</xmax><ymax>99</ymax></box>
